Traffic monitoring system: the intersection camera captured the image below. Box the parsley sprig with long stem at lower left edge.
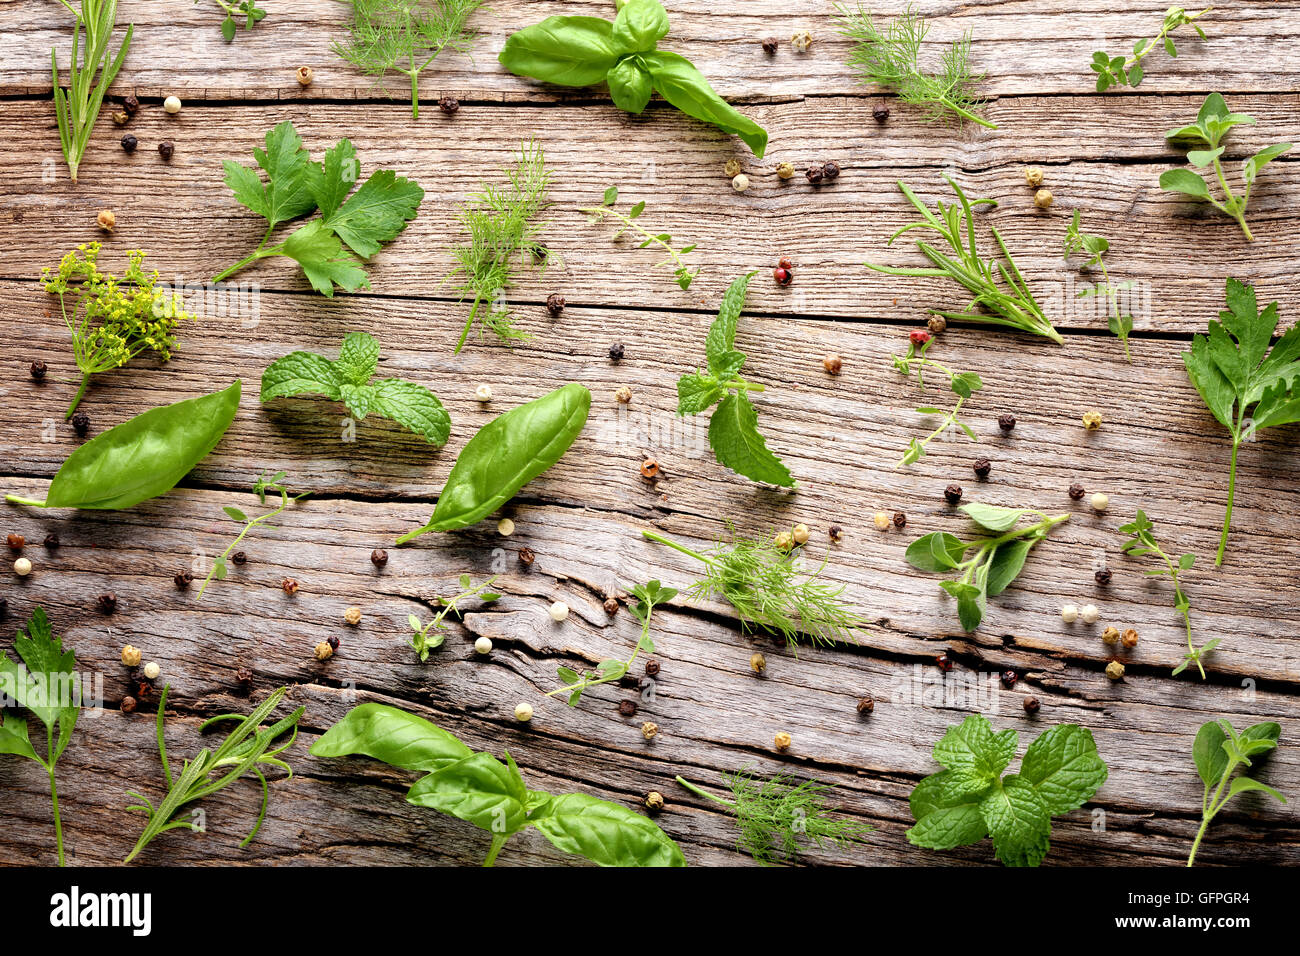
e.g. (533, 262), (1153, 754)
(0, 607), (81, 866)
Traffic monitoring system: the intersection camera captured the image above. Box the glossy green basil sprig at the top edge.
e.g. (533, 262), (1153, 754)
(498, 0), (767, 159)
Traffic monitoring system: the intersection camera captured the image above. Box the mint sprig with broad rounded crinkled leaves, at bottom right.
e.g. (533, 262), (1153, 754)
(907, 714), (1108, 866)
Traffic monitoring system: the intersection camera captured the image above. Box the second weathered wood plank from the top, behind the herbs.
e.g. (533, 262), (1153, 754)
(0, 95), (1300, 332)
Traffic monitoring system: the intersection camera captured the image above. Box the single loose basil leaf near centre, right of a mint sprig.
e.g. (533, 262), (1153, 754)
(398, 384), (592, 544)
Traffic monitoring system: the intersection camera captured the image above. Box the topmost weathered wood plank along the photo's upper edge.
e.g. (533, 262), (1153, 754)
(0, 0), (1300, 98)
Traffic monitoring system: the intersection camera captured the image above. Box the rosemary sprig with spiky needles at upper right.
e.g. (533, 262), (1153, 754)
(866, 177), (1063, 345)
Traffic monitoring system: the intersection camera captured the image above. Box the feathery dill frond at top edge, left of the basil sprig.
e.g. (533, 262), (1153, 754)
(332, 0), (484, 120)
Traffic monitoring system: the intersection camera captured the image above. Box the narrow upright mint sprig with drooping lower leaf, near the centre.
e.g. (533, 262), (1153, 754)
(677, 272), (794, 488)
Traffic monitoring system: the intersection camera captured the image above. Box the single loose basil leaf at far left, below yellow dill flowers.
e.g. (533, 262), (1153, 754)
(31, 380), (239, 510)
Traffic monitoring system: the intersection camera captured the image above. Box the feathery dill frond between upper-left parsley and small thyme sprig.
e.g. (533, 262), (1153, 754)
(447, 139), (551, 352)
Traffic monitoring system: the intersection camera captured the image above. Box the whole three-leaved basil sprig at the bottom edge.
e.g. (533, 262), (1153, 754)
(312, 704), (686, 866)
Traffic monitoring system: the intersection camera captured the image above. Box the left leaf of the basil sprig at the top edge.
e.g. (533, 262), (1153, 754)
(498, 17), (619, 86)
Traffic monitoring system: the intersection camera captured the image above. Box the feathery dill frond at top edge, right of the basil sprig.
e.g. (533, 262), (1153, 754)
(836, 4), (997, 130)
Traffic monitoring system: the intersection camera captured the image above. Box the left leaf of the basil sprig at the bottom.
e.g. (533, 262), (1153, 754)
(311, 702), (473, 771)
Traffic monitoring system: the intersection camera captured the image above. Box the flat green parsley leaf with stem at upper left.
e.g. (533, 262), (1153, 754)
(212, 120), (424, 297)
